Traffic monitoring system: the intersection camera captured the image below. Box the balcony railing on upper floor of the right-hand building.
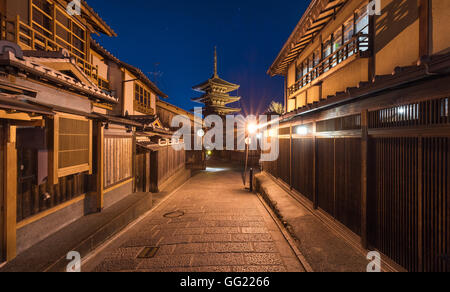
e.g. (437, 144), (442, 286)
(288, 33), (369, 96)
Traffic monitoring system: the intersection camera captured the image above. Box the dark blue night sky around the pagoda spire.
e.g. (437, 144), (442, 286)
(88, 0), (309, 114)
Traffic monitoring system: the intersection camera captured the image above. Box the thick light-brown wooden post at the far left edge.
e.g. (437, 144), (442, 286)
(3, 125), (17, 261)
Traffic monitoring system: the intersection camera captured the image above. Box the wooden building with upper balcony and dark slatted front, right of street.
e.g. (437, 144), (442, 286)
(264, 0), (450, 271)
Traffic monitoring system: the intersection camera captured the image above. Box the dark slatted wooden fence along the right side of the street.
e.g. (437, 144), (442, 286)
(263, 98), (450, 272)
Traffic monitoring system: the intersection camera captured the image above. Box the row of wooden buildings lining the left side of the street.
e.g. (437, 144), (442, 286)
(0, 0), (185, 262)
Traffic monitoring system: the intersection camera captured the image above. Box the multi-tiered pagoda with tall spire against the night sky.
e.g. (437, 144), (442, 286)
(192, 49), (241, 116)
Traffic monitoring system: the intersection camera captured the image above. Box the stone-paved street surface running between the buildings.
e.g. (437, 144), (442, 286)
(82, 168), (303, 272)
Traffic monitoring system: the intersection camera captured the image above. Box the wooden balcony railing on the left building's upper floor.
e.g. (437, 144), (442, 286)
(0, 15), (99, 84)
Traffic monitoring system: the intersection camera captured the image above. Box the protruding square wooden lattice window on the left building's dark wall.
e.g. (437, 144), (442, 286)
(53, 114), (92, 183)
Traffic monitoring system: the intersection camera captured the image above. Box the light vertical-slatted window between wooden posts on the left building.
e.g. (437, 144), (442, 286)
(104, 137), (133, 188)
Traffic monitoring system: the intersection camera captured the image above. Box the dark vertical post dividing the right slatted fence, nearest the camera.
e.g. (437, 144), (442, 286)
(361, 110), (369, 249)
